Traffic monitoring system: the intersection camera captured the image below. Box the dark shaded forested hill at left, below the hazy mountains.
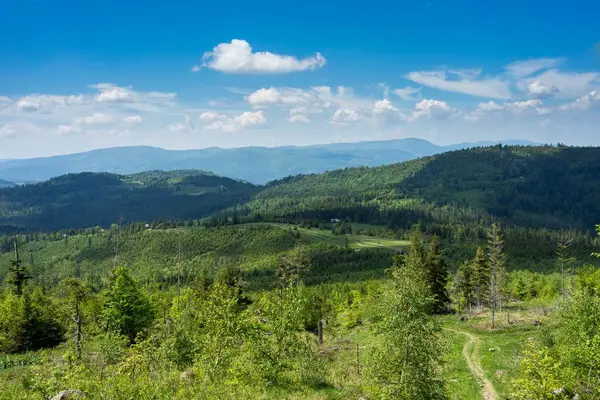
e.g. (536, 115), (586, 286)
(0, 170), (257, 230)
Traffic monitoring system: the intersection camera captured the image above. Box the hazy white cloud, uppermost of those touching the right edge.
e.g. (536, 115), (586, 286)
(520, 69), (600, 98)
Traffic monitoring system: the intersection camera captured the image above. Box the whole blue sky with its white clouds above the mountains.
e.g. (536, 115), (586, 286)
(0, 0), (600, 158)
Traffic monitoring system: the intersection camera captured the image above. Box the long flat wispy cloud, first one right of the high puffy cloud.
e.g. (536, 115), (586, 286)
(406, 71), (511, 99)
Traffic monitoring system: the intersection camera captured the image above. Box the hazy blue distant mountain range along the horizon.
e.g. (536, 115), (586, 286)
(0, 139), (536, 187)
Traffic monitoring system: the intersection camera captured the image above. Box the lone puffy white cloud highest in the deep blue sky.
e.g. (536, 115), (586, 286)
(199, 39), (326, 74)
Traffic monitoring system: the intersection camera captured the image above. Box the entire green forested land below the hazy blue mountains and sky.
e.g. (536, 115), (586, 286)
(0, 146), (600, 400)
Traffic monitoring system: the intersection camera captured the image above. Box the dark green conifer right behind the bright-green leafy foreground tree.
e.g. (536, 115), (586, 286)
(425, 235), (450, 314)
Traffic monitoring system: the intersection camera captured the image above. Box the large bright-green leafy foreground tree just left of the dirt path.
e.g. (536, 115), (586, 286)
(367, 232), (446, 399)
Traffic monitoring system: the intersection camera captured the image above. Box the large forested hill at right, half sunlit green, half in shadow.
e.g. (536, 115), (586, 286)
(247, 146), (600, 229)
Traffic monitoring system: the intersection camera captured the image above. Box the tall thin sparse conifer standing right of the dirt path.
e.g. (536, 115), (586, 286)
(487, 223), (506, 329)
